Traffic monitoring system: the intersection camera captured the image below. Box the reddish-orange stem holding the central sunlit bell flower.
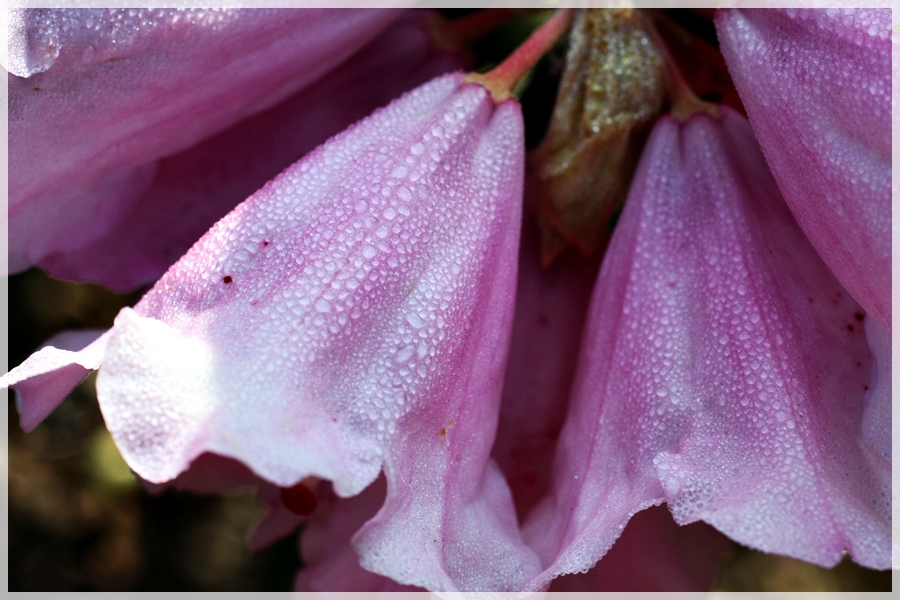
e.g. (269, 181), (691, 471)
(466, 8), (572, 102)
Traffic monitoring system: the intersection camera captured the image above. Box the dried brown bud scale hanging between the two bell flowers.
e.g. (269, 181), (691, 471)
(532, 9), (666, 263)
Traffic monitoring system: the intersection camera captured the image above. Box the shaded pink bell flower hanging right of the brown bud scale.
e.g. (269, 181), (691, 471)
(524, 108), (890, 589)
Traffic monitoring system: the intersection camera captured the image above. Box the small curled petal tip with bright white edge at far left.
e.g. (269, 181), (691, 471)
(0, 329), (109, 431)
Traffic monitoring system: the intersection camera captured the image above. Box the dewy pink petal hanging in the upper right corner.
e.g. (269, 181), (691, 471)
(716, 9), (891, 331)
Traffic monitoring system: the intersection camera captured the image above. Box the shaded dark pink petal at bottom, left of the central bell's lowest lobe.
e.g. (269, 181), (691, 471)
(294, 477), (421, 592)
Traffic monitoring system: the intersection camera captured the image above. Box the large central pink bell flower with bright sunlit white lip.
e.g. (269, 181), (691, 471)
(97, 74), (537, 589)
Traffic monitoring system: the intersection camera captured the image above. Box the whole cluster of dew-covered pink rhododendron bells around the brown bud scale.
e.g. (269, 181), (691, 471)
(0, 5), (891, 591)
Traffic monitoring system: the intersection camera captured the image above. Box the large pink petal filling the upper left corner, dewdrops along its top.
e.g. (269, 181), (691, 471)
(6, 9), (398, 272)
